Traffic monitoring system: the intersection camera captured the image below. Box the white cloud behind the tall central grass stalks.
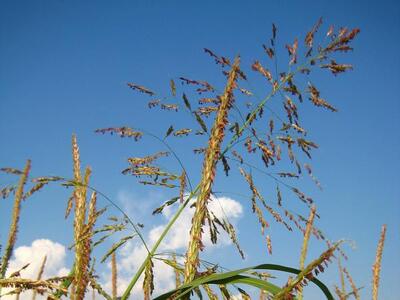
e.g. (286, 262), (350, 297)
(104, 197), (243, 299)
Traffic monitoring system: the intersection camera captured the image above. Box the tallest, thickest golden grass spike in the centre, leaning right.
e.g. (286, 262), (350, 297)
(185, 57), (240, 283)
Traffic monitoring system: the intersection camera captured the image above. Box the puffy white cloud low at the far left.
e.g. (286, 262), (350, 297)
(2, 239), (69, 300)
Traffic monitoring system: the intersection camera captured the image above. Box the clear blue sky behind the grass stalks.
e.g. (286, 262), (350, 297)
(0, 0), (400, 300)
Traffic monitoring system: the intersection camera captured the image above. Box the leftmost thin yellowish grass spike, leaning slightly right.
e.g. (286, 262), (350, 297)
(0, 160), (31, 280)
